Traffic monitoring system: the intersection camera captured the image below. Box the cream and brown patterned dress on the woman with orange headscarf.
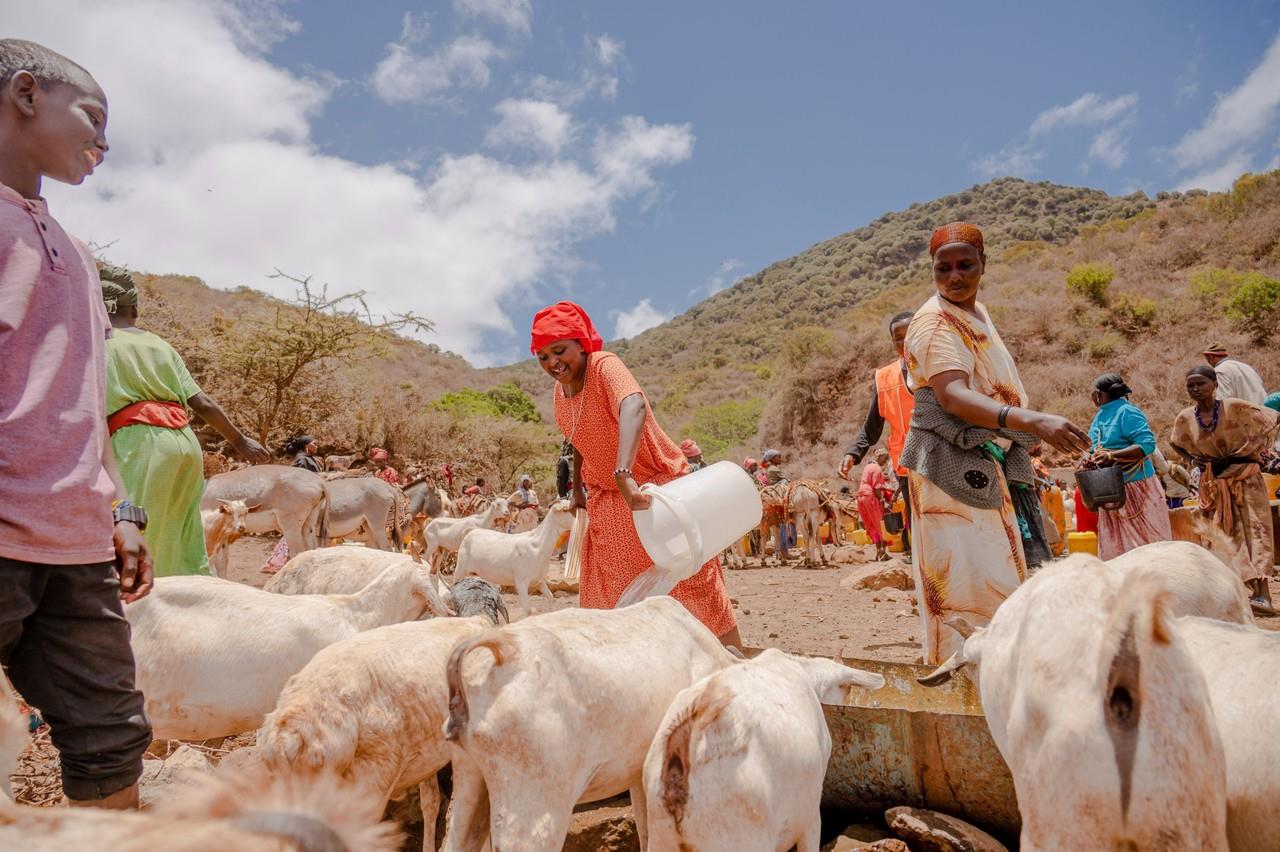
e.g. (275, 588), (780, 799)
(906, 296), (1027, 665)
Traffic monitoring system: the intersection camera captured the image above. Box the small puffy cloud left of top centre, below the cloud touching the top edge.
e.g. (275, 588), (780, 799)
(374, 36), (502, 104)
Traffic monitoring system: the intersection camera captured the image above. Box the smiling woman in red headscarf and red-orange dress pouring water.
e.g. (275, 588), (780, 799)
(530, 302), (742, 647)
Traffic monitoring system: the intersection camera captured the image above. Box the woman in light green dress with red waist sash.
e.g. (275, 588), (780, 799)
(100, 266), (270, 577)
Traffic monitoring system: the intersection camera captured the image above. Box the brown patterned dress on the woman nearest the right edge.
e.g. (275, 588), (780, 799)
(1170, 399), (1280, 582)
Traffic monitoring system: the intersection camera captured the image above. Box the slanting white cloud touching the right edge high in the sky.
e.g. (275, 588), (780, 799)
(1172, 36), (1280, 169)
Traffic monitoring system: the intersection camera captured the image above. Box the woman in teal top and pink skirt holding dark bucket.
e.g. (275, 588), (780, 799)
(1089, 372), (1174, 559)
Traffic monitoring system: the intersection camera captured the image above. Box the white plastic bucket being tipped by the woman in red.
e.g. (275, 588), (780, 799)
(617, 462), (764, 606)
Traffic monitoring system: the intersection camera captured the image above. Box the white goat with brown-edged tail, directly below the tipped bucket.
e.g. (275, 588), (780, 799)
(444, 596), (736, 852)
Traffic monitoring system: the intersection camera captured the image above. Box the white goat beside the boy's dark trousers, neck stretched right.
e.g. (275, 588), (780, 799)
(124, 572), (448, 739)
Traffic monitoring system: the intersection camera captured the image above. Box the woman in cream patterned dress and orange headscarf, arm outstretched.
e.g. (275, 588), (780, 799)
(906, 223), (1089, 665)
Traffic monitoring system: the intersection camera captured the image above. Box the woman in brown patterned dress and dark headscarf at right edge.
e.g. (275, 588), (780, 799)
(1170, 365), (1280, 614)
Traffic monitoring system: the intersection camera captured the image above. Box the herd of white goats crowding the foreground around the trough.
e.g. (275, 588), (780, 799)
(0, 491), (1280, 852)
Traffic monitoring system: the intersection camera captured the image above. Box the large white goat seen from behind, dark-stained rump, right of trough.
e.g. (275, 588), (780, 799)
(922, 556), (1228, 852)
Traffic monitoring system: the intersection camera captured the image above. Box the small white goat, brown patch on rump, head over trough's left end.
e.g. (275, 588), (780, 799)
(644, 650), (884, 852)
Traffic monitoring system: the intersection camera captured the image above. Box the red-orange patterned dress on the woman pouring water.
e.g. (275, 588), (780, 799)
(556, 352), (736, 636)
